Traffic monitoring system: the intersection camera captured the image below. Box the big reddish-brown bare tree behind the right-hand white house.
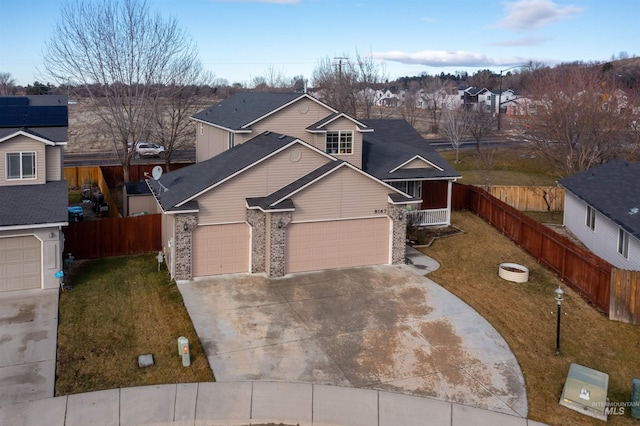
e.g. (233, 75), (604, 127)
(525, 64), (633, 177)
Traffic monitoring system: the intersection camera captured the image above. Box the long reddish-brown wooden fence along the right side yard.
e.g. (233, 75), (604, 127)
(452, 184), (612, 314)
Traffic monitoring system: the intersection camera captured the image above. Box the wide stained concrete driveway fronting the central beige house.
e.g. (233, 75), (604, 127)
(178, 265), (527, 417)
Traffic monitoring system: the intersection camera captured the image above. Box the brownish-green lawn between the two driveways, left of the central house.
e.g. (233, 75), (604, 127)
(55, 255), (214, 396)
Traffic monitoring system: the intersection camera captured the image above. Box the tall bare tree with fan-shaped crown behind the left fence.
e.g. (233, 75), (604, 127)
(44, 0), (204, 182)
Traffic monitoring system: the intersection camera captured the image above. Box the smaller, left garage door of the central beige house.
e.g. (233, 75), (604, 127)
(193, 223), (250, 277)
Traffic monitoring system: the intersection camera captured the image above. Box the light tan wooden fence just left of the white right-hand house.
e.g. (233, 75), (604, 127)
(488, 185), (564, 212)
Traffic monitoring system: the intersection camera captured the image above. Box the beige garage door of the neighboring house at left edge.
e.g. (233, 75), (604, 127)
(0, 236), (42, 291)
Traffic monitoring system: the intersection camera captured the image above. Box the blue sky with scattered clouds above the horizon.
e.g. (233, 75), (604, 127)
(0, 0), (640, 85)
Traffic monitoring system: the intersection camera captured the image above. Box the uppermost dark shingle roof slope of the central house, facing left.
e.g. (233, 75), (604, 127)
(193, 92), (306, 130)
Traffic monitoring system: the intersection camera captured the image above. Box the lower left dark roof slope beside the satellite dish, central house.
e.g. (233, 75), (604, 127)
(148, 132), (296, 211)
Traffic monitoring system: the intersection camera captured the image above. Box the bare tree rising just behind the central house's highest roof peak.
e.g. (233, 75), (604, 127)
(313, 53), (385, 118)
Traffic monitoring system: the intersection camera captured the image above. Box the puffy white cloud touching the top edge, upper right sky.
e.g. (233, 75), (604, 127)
(496, 0), (582, 30)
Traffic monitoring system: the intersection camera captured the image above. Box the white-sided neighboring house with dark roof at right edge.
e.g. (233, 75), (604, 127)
(559, 160), (640, 270)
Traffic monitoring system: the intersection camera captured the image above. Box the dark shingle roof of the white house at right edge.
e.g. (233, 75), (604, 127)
(558, 160), (640, 238)
